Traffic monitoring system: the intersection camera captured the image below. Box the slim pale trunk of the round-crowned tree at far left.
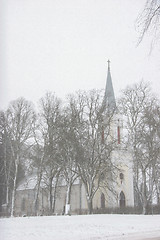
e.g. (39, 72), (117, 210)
(11, 158), (19, 217)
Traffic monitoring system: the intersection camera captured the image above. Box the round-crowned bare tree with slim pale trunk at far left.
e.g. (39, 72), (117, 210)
(6, 98), (35, 216)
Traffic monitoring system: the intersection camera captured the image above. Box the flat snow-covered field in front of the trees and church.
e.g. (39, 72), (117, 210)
(0, 215), (160, 240)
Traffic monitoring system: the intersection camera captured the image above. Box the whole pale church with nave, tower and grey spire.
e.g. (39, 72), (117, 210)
(15, 61), (134, 216)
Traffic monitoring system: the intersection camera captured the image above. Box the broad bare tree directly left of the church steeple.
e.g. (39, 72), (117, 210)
(67, 90), (114, 214)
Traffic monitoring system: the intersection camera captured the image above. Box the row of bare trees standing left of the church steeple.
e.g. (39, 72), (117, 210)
(0, 91), (114, 216)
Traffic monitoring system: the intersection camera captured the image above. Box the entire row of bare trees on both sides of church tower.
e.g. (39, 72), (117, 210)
(0, 83), (160, 216)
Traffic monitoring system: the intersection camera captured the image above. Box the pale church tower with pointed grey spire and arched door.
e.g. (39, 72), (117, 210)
(103, 60), (134, 209)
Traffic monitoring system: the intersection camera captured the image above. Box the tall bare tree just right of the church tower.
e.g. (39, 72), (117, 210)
(121, 82), (159, 214)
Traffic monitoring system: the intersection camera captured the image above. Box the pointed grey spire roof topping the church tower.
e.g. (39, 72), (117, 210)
(104, 60), (116, 110)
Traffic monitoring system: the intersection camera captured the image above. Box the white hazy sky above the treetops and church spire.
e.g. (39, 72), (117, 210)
(0, 0), (160, 109)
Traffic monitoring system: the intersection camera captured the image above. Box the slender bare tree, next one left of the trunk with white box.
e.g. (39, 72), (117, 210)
(39, 93), (61, 213)
